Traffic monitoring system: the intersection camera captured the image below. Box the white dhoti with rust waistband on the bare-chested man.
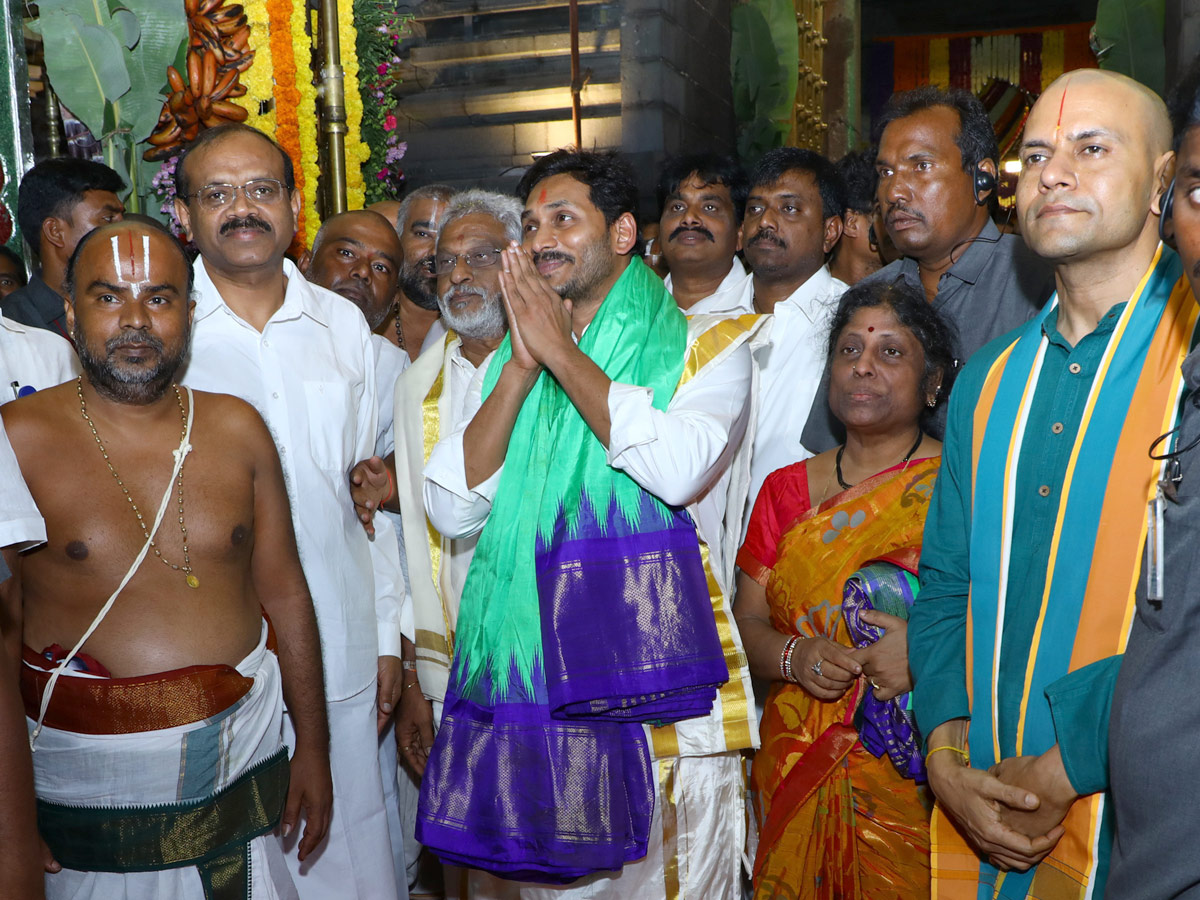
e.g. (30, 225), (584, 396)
(23, 623), (298, 900)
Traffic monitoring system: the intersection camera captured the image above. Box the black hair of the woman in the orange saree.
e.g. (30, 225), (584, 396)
(826, 278), (958, 416)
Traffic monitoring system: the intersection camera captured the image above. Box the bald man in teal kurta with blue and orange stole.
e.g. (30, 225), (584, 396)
(908, 68), (1176, 900)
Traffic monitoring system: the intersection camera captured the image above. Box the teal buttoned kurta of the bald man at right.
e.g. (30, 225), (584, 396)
(908, 304), (1126, 793)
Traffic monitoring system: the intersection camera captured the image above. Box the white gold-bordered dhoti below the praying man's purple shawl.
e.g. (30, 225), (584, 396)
(469, 751), (746, 900)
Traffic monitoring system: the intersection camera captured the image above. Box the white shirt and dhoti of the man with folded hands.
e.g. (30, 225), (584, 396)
(425, 321), (757, 900)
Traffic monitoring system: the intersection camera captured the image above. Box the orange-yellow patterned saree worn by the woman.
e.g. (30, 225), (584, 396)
(751, 458), (941, 900)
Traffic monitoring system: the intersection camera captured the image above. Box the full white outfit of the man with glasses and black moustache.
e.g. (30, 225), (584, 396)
(181, 259), (407, 900)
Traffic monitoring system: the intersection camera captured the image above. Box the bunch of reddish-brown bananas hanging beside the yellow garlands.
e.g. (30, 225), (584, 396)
(143, 0), (254, 160)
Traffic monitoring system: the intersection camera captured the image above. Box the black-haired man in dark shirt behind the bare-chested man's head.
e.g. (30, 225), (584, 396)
(0, 157), (125, 340)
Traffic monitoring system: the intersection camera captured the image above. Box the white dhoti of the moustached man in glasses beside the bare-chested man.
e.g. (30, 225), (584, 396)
(283, 682), (408, 900)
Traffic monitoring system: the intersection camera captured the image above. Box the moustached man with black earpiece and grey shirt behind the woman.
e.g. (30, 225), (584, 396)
(802, 85), (1054, 454)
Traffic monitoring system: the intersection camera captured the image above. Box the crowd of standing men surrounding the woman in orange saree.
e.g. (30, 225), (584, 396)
(0, 60), (1200, 900)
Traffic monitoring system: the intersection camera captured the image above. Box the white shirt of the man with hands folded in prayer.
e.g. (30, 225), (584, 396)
(425, 336), (752, 573)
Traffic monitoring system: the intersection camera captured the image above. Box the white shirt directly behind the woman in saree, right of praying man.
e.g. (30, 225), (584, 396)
(743, 265), (848, 509)
